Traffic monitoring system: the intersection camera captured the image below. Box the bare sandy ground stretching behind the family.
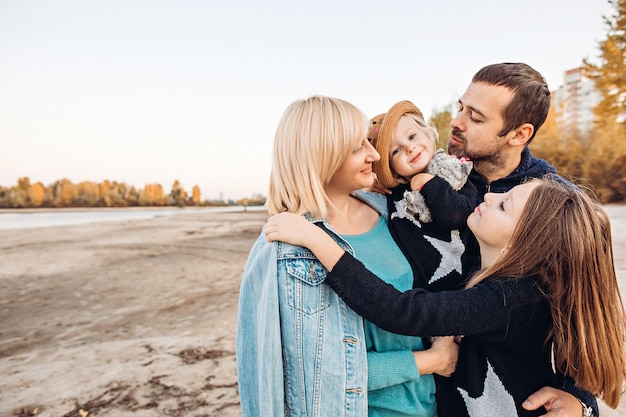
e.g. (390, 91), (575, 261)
(0, 206), (626, 417)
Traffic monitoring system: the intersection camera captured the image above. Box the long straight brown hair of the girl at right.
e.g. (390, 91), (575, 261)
(468, 179), (626, 408)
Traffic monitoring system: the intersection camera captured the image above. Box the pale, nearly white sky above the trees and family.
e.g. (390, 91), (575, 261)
(0, 0), (613, 199)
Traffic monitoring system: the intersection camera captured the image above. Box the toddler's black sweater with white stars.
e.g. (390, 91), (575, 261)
(387, 176), (478, 291)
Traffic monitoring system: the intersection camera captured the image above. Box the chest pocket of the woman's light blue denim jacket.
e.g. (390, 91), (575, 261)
(287, 258), (332, 314)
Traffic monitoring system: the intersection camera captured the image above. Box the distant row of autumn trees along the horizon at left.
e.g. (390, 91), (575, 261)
(0, 177), (265, 208)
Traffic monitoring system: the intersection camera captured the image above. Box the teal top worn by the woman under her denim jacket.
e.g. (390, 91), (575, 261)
(342, 216), (437, 417)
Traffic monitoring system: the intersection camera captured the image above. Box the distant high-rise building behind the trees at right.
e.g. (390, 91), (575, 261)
(552, 67), (602, 135)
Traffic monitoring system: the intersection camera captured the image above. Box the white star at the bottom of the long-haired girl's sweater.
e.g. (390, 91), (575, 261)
(457, 361), (517, 417)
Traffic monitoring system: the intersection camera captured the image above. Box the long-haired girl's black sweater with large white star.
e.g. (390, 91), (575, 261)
(325, 253), (557, 417)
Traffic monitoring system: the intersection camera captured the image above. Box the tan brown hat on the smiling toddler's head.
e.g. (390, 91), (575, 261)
(367, 100), (424, 188)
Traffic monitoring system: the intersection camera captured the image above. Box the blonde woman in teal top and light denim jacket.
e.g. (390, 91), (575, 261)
(237, 96), (458, 417)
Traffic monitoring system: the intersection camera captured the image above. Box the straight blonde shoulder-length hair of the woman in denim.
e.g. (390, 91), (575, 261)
(267, 96), (368, 217)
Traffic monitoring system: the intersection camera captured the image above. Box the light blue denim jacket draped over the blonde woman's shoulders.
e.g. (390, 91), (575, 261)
(237, 193), (387, 417)
